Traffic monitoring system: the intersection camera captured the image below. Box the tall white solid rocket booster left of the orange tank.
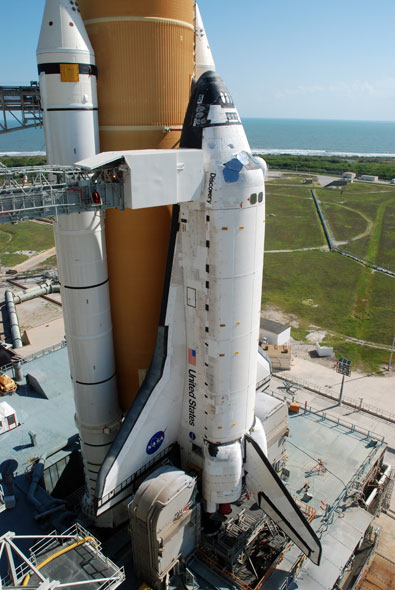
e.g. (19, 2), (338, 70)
(37, 0), (121, 504)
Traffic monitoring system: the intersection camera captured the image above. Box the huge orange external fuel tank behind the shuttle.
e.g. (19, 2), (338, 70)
(78, 0), (195, 409)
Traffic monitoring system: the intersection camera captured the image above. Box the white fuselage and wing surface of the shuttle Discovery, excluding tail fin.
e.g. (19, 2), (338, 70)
(99, 91), (265, 511)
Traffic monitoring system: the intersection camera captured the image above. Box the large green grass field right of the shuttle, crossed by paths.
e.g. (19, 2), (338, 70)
(262, 179), (395, 371)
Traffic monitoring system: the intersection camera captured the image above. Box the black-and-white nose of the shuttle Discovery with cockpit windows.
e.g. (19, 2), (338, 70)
(180, 71), (241, 149)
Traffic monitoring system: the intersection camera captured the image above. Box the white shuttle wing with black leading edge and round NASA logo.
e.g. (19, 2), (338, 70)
(95, 205), (187, 516)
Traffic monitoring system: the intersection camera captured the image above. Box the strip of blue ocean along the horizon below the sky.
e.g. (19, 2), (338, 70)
(0, 118), (395, 157)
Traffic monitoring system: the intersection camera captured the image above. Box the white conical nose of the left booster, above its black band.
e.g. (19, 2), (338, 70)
(37, 0), (95, 64)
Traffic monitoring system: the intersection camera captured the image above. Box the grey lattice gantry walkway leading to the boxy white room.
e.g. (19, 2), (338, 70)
(0, 162), (124, 223)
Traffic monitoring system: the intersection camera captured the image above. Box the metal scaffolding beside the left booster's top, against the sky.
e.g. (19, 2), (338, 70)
(0, 82), (43, 134)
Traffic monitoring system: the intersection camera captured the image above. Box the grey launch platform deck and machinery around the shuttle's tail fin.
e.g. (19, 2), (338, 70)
(189, 411), (386, 590)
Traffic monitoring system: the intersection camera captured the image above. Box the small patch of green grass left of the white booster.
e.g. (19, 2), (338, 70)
(0, 221), (55, 266)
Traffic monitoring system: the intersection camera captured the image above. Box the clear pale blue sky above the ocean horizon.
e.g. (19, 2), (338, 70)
(0, 0), (395, 121)
